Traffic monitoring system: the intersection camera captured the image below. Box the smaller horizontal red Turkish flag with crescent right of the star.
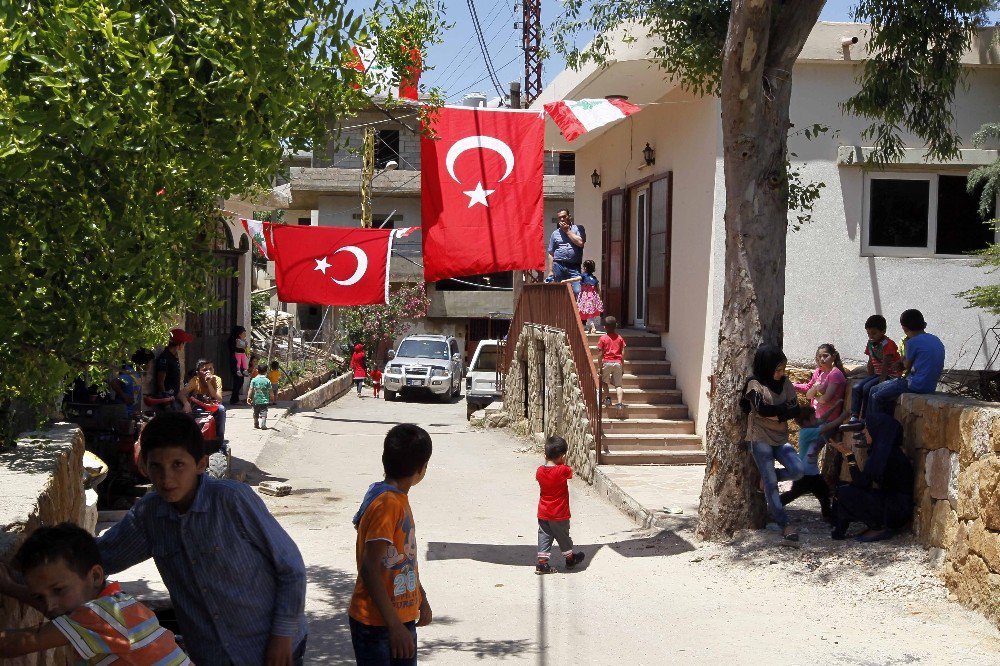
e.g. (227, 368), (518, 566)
(270, 224), (394, 305)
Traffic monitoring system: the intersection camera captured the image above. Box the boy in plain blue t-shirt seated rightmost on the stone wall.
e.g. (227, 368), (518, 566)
(869, 310), (944, 416)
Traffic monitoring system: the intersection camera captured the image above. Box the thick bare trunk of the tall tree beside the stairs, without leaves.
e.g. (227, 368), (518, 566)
(698, 0), (824, 539)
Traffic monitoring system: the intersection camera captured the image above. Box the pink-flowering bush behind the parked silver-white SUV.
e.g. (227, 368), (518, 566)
(337, 282), (430, 358)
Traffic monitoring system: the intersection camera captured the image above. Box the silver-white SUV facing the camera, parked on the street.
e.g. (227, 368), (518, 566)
(382, 335), (462, 402)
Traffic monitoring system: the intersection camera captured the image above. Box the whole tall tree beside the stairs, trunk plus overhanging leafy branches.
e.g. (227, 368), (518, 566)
(553, 0), (994, 538)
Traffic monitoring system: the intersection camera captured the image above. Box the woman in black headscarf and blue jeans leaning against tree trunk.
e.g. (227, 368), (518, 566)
(740, 344), (803, 541)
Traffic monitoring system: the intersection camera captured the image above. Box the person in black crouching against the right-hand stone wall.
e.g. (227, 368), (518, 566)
(830, 413), (913, 543)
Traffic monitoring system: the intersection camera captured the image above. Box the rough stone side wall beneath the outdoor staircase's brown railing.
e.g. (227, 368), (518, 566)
(503, 324), (597, 483)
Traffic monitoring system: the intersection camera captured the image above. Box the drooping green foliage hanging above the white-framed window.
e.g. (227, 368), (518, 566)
(843, 0), (997, 163)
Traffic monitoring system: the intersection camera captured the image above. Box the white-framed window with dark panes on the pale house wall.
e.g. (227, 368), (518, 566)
(862, 172), (996, 257)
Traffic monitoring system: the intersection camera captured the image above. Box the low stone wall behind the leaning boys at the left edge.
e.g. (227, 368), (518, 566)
(0, 423), (84, 665)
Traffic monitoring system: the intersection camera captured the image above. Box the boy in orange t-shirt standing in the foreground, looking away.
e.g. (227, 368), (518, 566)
(347, 423), (431, 664)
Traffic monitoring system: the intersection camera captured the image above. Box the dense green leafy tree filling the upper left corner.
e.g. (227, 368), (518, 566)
(0, 0), (441, 434)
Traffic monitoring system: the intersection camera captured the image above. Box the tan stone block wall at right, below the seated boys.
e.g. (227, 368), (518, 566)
(896, 393), (1000, 626)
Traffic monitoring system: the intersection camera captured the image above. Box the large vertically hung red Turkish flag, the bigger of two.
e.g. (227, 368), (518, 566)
(420, 107), (545, 282)
